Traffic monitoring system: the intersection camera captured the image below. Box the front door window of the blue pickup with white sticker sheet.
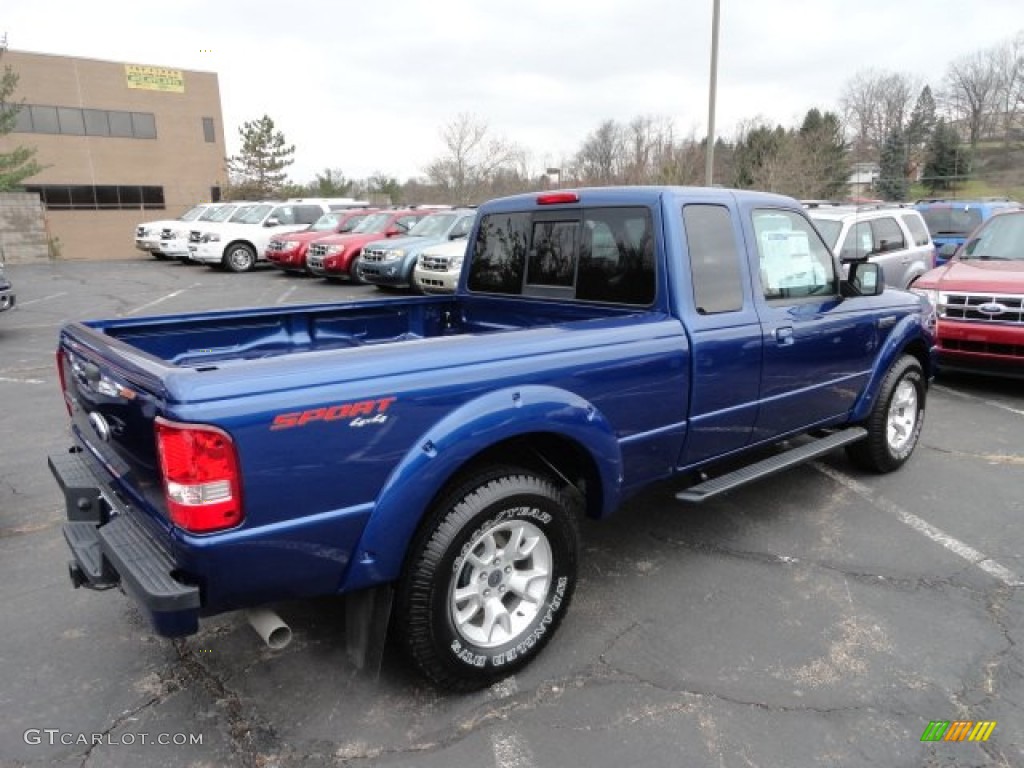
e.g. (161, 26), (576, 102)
(753, 209), (838, 300)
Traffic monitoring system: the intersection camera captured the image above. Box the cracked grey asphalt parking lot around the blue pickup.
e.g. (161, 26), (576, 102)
(0, 258), (1024, 768)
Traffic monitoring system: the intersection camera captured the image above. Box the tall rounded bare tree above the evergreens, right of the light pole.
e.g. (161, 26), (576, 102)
(840, 70), (921, 158)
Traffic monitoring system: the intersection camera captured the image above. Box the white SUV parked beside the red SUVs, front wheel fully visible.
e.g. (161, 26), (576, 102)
(188, 202), (330, 272)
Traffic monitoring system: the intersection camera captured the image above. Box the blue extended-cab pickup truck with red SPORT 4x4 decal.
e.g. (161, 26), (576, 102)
(50, 187), (935, 689)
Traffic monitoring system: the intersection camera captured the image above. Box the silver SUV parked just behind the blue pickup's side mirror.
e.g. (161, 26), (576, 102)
(804, 202), (935, 289)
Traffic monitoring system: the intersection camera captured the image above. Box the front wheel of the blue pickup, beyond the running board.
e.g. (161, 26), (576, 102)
(846, 354), (927, 473)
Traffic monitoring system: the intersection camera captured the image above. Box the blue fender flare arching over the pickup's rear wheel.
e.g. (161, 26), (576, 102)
(341, 385), (623, 592)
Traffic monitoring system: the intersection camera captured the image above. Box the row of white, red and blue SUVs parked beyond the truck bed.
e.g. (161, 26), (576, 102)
(135, 200), (476, 293)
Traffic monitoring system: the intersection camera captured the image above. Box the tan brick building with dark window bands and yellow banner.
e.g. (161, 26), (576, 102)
(0, 50), (226, 259)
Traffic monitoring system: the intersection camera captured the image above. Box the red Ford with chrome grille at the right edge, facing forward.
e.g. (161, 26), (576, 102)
(910, 210), (1024, 378)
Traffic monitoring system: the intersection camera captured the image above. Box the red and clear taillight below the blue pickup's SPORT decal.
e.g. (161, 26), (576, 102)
(156, 417), (242, 534)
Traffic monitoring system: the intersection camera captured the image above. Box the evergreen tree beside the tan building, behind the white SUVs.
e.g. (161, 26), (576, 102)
(227, 115), (295, 200)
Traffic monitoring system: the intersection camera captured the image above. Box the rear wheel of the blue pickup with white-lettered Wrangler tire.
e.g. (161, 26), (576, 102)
(396, 467), (579, 691)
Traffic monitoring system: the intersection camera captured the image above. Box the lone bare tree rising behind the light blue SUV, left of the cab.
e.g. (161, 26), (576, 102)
(426, 113), (524, 203)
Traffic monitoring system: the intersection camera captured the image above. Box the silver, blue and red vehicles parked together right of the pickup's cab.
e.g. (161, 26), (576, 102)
(804, 198), (1024, 378)
